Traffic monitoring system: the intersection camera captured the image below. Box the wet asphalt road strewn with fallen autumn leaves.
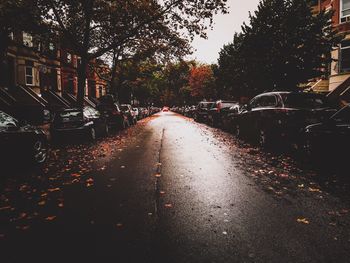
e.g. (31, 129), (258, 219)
(0, 112), (350, 263)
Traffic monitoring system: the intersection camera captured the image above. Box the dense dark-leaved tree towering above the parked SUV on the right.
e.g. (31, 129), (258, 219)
(219, 0), (339, 96)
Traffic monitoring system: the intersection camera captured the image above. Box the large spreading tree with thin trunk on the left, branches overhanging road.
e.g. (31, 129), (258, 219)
(38, 0), (226, 104)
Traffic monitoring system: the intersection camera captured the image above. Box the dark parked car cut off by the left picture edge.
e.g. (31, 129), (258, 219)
(0, 111), (48, 164)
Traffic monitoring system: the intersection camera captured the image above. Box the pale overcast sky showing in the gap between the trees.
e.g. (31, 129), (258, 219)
(190, 0), (259, 64)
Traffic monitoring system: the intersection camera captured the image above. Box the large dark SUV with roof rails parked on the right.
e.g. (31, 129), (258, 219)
(235, 92), (336, 146)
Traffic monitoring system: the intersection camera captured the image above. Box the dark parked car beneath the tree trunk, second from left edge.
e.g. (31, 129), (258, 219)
(50, 106), (109, 140)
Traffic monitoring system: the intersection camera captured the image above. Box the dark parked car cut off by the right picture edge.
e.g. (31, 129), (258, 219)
(305, 106), (350, 162)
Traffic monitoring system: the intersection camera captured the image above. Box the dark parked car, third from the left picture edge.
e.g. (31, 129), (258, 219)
(97, 101), (129, 129)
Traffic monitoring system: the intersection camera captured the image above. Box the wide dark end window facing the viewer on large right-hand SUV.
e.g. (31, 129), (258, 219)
(282, 93), (329, 109)
